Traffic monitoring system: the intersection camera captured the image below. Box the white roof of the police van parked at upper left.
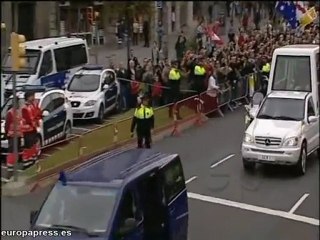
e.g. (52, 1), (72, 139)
(26, 37), (85, 50)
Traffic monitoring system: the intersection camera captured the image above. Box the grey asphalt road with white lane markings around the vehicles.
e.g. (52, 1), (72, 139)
(1, 109), (319, 240)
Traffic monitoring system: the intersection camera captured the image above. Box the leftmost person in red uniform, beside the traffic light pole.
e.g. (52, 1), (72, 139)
(1, 98), (23, 182)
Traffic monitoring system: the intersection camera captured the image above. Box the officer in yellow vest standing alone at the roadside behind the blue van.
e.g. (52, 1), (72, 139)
(131, 95), (154, 148)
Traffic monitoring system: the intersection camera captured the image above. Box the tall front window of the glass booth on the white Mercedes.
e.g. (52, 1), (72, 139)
(272, 55), (312, 92)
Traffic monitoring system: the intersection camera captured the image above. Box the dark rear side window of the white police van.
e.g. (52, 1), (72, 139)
(54, 44), (88, 72)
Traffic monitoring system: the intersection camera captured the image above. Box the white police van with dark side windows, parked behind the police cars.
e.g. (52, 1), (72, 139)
(1, 37), (89, 97)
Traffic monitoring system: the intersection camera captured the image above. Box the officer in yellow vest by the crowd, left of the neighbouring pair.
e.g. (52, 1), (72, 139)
(168, 61), (181, 103)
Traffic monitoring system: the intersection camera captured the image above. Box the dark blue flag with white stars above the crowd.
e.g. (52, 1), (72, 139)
(276, 1), (298, 29)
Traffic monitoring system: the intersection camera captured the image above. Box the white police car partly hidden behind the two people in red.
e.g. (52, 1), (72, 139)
(1, 85), (73, 152)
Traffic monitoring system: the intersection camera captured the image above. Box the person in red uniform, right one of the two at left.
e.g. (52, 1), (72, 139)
(22, 91), (38, 169)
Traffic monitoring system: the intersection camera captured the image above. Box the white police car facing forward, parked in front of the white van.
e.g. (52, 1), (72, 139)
(65, 65), (120, 123)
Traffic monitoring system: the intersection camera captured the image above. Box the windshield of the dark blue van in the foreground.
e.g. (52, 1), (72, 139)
(35, 184), (118, 233)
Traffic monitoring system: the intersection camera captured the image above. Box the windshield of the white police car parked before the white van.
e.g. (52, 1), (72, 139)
(68, 74), (100, 92)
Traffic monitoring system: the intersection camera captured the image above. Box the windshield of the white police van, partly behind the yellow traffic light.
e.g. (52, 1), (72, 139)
(1, 49), (41, 74)
